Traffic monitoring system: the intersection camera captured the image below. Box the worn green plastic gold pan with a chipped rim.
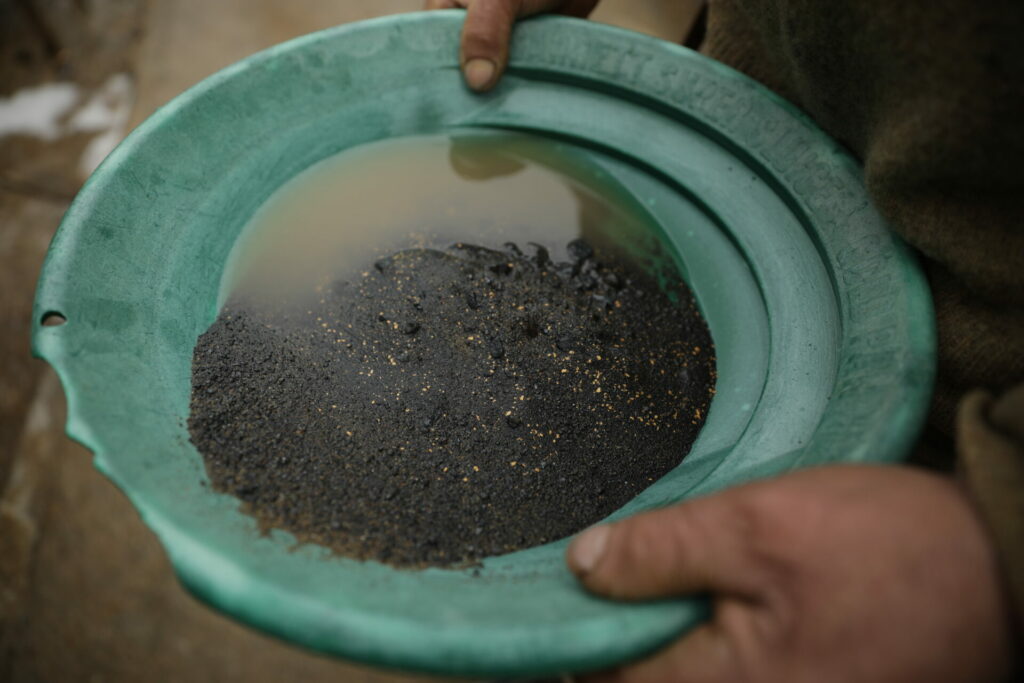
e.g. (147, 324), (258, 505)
(33, 12), (935, 677)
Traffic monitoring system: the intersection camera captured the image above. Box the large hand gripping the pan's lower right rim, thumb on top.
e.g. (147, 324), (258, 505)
(567, 466), (1013, 683)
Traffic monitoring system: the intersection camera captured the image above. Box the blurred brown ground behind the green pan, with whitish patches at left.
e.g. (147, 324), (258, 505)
(0, 0), (699, 683)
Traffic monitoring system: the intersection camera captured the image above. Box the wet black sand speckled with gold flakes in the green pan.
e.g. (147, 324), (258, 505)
(188, 242), (715, 565)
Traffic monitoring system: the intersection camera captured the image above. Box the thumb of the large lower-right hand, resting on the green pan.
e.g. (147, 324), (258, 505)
(566, 489), (763, 600)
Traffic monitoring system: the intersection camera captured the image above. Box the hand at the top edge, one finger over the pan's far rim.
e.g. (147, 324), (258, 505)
(426, 0), (598, 92)
